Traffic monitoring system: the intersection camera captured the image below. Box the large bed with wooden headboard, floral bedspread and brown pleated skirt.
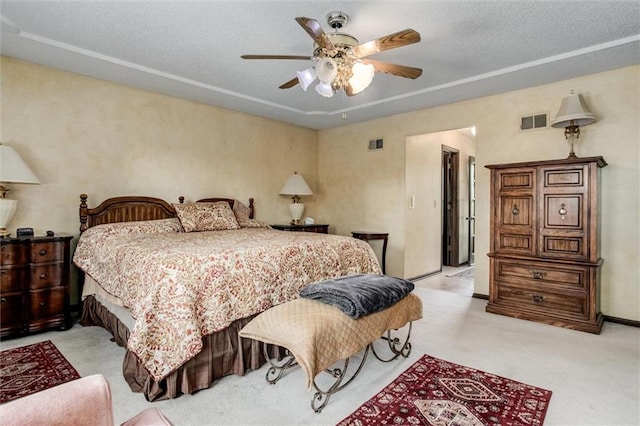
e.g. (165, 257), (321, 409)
(74, 194), (380, 401)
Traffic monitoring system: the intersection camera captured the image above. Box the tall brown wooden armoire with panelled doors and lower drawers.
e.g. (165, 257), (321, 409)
(486, 157), (607, 334)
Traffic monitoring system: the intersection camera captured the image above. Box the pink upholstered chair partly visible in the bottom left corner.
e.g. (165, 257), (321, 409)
(0, 374), (172, 426)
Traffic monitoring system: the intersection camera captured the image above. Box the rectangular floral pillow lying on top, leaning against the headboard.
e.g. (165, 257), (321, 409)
(173, 201), (240, 232)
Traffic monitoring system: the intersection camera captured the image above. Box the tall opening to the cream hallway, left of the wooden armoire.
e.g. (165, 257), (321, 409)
(404, 127), (475, 278)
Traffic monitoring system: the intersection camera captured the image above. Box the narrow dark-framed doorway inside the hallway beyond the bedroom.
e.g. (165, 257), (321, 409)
(442, 145), (460, 266)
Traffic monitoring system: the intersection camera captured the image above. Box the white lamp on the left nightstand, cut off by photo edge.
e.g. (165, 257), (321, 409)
(0, 143), (40, 238)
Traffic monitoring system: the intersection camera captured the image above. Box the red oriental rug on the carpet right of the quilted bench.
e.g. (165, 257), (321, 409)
(339, 355), (551, 426)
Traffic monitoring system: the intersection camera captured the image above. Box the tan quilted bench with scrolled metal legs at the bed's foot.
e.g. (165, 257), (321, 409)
(240, 274), (422, 412)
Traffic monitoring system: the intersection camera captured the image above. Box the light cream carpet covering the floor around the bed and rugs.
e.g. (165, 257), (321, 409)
(0, 285), (640, 426)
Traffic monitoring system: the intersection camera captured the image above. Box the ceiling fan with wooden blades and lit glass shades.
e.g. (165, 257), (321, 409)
(241, 11), (422, 97)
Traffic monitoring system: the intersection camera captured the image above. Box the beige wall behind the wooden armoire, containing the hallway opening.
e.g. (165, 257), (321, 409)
(318, 66), (640, 320)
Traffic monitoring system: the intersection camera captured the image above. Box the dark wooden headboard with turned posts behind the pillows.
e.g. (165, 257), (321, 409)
(79, 194), (255, 233)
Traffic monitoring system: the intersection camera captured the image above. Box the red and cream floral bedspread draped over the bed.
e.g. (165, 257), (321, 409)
(74, 219), (380, 380)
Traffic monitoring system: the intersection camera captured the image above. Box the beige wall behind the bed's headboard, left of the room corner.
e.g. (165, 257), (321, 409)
(0, 57), (318, 302)
